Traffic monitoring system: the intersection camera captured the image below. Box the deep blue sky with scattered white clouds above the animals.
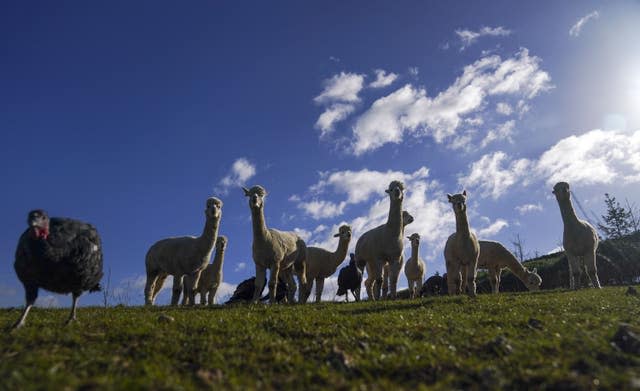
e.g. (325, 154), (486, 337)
(0, 1), (640, 306)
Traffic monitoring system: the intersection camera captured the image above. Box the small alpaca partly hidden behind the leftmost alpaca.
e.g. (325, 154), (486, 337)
(182, 235), (227, 305)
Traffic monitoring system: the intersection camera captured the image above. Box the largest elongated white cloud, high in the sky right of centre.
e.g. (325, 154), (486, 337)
(351, 49), (552, 156)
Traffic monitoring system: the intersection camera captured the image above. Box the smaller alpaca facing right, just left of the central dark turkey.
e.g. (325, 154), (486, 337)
(301, 225), (351, 303)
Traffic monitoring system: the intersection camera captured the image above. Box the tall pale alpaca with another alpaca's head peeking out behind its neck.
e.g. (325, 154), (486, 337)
(355, 181), (404, 300)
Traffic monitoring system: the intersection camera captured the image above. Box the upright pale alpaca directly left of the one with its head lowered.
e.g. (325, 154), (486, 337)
(444, 190), (480, 297)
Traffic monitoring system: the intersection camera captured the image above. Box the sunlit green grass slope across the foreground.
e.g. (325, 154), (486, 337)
(0, 287), (640, 390)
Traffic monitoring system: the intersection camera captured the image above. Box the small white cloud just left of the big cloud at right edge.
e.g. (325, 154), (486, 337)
(458, 151), (531, 199)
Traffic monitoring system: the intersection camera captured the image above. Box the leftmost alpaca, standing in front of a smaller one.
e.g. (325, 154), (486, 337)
(144, 197), (222, 305)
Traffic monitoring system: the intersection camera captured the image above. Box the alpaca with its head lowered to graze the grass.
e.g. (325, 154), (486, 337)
(478, 240), (542, 293)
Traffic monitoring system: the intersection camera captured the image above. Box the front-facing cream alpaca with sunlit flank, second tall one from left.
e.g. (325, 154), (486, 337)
(242, 186), (307, 303)
